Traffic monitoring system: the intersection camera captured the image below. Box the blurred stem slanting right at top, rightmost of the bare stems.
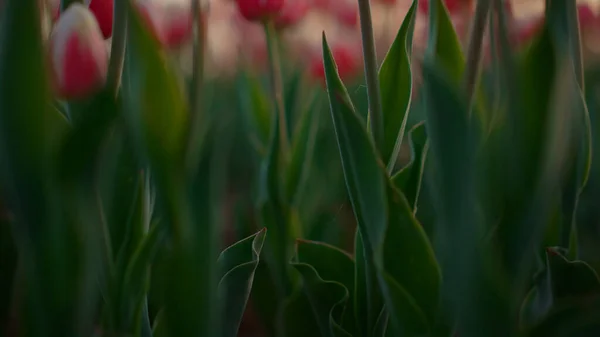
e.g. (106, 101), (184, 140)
(464, 0), (491, 111)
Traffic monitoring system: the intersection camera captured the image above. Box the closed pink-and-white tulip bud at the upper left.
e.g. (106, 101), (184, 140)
(50, 3), (108, 99)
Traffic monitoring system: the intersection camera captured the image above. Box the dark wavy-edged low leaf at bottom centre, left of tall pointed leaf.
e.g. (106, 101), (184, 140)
(292, 262), (352, 337)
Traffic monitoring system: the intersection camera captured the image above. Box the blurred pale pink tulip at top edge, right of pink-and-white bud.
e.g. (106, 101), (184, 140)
(137, 1), (194, 48)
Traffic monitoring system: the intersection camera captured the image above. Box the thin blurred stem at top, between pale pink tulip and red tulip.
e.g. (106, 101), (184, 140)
(187, 0), (207, 174)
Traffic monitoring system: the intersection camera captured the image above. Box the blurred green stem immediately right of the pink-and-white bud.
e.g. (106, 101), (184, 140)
(106, 0), (127, 97)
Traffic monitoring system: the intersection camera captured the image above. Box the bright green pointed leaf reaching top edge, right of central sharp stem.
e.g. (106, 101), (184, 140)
(379, 1), (418, 168)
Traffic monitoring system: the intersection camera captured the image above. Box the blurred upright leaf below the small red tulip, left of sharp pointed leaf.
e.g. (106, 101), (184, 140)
(286, 90), (320, 205)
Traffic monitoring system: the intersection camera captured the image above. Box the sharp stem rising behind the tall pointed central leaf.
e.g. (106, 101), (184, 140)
(358, 0), (383, 150)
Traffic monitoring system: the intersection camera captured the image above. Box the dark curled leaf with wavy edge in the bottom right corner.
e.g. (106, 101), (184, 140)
(520, 247), (600, 329)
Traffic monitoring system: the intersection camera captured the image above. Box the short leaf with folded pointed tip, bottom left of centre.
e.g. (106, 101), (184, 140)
(217, 229), (267, 337)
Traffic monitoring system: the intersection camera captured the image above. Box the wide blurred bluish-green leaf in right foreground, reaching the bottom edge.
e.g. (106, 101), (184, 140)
(423, 62), (513, 337)
